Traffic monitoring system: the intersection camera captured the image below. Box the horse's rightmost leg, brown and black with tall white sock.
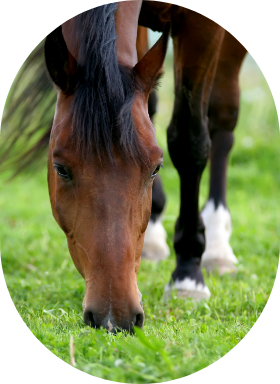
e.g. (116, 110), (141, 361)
(201, 31), (247, 275)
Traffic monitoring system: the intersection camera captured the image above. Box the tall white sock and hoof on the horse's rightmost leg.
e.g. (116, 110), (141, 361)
(201, 200), (238, 275)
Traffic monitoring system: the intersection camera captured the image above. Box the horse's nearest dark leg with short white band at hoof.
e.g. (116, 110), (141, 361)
(165, 7), (224, 299)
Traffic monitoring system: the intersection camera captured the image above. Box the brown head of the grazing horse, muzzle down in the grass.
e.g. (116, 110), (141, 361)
(45, 11), (169, 332)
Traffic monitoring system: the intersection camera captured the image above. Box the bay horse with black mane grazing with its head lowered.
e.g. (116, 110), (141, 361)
(2, 0), (246, 332)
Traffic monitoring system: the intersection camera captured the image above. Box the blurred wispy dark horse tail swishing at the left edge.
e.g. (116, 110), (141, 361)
(0, 39), (56, 177)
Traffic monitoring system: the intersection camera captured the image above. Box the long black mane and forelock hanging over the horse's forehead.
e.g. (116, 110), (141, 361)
(69, 3), (145, 164)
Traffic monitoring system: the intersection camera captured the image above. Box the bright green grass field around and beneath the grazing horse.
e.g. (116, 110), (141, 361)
(0, 36), (280, 383)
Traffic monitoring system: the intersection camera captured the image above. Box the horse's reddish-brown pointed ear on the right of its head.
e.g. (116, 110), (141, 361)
(134, 23), (170, 94)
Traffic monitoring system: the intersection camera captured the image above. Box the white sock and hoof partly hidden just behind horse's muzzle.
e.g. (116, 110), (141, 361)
(142, 220), (170, 261)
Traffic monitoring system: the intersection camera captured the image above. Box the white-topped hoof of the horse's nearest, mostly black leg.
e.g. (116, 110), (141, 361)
(163, 277), (211, 300)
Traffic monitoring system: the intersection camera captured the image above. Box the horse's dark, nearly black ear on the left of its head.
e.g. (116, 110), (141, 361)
(45, 25), (77, 94)
